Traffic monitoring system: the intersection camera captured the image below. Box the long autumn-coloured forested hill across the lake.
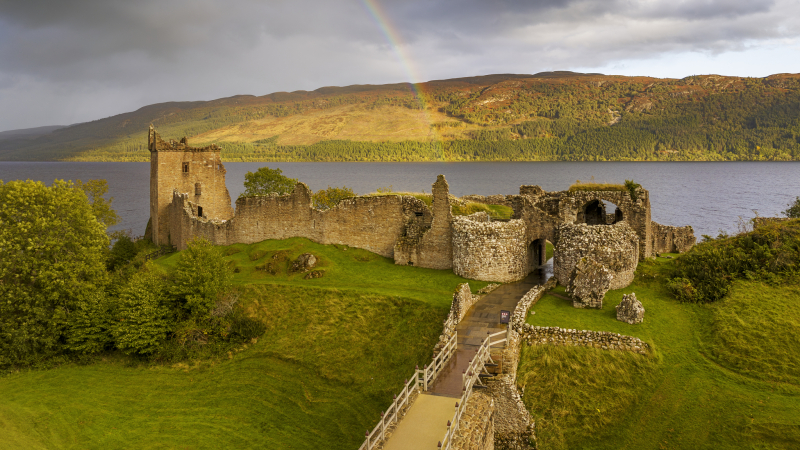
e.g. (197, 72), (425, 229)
(0, 72), (800, 161)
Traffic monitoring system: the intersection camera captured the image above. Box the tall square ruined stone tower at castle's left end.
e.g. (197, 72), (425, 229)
(147, 125), (233, 245)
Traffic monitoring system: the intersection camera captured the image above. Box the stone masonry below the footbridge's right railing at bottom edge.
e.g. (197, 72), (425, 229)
(450, 391), (495, 450)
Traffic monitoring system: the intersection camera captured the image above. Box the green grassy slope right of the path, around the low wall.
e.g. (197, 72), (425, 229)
(520, 258), (800, 449)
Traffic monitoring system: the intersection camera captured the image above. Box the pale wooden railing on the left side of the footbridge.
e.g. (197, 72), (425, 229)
(358, 332), (458, 450)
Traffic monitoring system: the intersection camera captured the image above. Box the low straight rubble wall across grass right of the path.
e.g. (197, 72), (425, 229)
(520, 324), (650, 355)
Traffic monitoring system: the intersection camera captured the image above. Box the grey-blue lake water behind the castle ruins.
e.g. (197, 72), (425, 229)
(0, 162), (800, 238)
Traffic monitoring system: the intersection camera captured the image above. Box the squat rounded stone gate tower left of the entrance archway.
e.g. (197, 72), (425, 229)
(453, 215), (529, 282)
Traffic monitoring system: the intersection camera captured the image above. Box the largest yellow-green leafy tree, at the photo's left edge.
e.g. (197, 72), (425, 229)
(0, 180), (108, 366)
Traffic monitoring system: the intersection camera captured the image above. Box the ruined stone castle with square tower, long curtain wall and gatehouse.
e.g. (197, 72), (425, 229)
(148, 127), (695, 282)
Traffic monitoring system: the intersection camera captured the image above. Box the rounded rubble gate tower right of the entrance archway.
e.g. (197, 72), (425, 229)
(553, 222), (640, 290)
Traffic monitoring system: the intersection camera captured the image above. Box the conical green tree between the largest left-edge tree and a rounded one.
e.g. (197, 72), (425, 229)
(111, 263), (171, 355)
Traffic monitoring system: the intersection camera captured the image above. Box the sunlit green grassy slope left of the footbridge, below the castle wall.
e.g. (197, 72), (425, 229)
(0, 239), (486, 449)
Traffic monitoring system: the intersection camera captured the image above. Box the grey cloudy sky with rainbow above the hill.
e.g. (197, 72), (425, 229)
(0, 0), (800, 131)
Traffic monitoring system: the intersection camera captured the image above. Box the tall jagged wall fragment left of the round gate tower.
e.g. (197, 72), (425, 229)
(394, 175), (453, 269)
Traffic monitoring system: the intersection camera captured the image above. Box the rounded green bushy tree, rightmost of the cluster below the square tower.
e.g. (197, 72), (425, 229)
(169, 239), (233, 318)
